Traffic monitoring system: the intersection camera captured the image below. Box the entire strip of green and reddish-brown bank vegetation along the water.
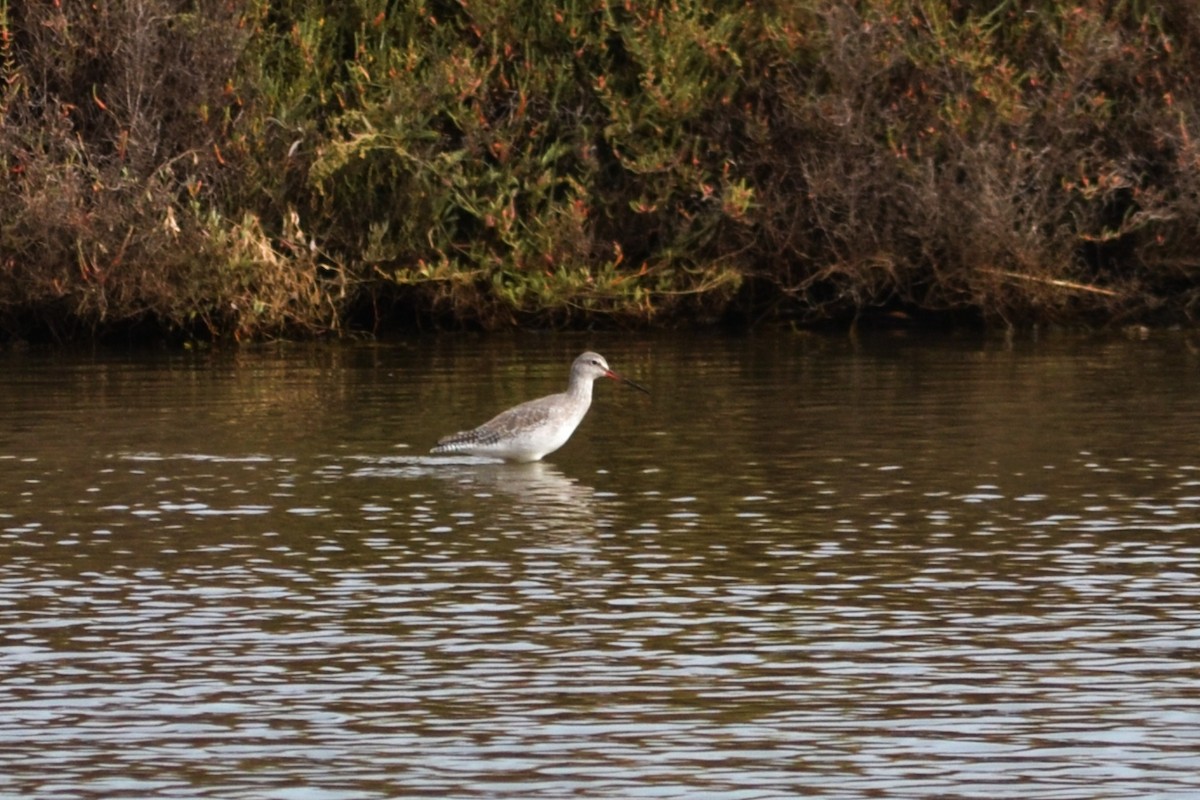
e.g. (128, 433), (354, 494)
(0, 0), (1200, 338)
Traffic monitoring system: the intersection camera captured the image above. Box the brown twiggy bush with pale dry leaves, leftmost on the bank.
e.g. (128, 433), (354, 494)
(0, 0), (340, 338)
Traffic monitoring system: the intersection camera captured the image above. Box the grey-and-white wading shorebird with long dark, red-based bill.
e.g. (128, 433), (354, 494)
(430, 353), (650, 462)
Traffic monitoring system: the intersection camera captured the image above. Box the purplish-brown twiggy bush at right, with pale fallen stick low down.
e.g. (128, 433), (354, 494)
(754, 2), (1200, 319)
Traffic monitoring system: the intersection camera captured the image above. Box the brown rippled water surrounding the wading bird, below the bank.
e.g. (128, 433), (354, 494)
(0, 335), (1200, 799)
